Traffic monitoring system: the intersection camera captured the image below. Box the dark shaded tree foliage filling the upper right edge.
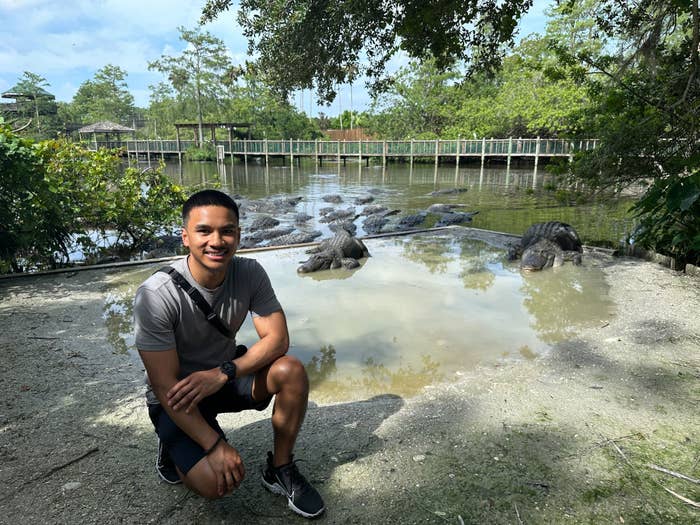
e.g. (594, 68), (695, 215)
(558, 0), (700, 264)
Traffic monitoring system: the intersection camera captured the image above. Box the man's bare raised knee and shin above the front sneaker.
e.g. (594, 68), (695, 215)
(253, 355), (309, 467)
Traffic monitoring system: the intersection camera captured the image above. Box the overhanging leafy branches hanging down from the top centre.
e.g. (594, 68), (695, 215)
(202, 0), (532, 102)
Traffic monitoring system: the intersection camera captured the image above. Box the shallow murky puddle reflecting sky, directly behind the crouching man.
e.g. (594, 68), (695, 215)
(105, 228), (613, 401)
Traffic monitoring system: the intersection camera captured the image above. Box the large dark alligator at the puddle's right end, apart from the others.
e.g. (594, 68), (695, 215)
(508, 221), (583, 271)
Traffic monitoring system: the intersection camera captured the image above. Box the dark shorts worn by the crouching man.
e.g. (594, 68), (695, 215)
(148, 375), (272, 474)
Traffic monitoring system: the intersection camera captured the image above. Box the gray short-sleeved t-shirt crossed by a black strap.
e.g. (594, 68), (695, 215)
(134, 257), (282, 378)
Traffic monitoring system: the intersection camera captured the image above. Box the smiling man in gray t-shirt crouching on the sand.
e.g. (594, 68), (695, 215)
(134, 190), (325, 518)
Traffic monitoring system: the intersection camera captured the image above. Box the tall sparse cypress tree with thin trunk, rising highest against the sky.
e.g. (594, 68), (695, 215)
(148, 27), (232, 145)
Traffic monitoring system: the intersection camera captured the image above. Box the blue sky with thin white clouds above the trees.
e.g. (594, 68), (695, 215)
(0, 0), (553, 115)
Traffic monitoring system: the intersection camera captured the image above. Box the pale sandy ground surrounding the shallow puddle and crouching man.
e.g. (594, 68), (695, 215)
(0, 243), (700, 524)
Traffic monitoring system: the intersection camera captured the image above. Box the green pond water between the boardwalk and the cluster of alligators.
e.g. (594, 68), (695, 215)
(161, 159), (632, 244)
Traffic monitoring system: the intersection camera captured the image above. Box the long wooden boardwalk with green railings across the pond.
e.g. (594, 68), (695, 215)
(88, 137), (597, 171)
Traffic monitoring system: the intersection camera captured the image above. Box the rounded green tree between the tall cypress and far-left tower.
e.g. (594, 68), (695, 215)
(71, 64), (135, 123)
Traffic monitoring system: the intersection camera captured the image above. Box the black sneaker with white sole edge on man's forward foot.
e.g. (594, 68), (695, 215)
(262, 452), (326, 518)
